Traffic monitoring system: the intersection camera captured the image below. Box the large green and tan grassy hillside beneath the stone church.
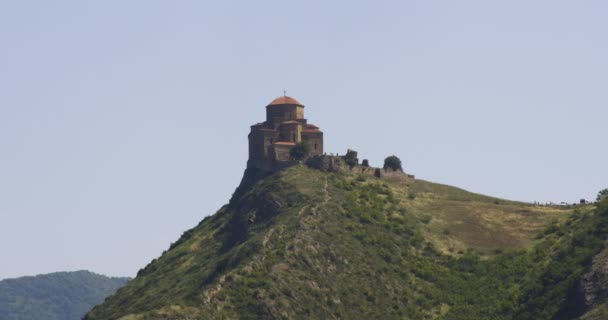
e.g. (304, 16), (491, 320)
(86, 165), (608, 320)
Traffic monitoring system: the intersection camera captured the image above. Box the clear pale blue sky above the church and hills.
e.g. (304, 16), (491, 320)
(0, 0), (608, 278)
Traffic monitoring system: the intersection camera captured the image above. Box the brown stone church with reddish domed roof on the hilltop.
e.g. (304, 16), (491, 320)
(247, 96), (323, 170)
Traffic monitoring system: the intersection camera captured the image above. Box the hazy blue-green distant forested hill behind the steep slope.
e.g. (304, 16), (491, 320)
(0, 271), (128, 320)
